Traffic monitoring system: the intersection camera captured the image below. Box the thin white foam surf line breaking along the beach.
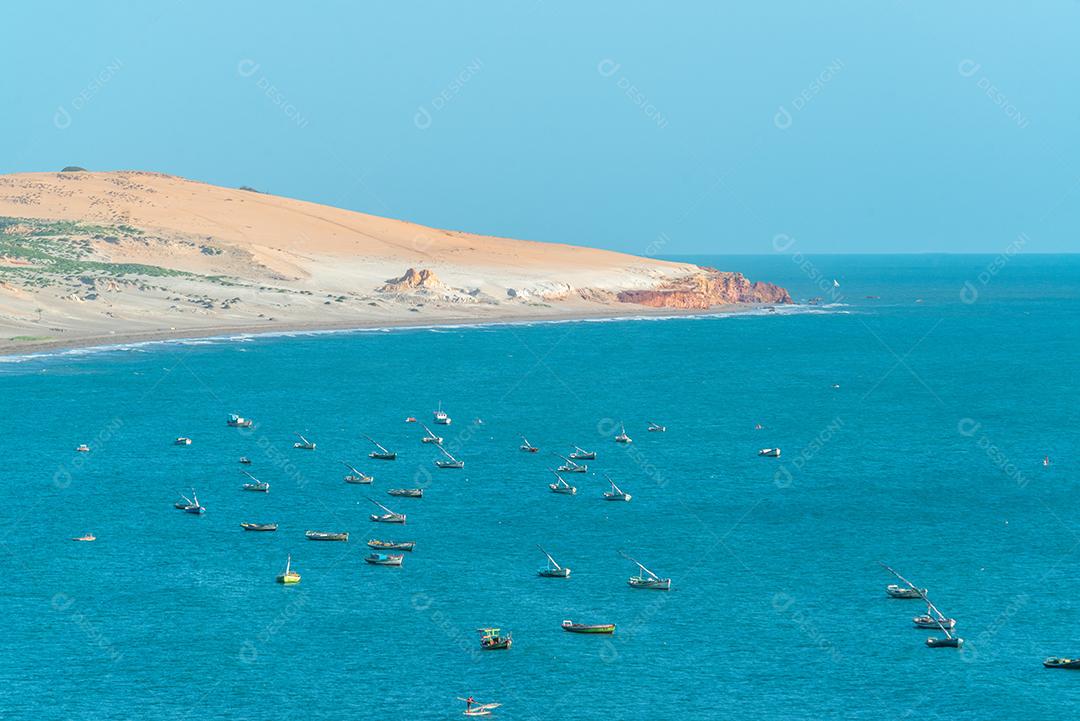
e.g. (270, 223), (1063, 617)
(0, 304), (848, 364)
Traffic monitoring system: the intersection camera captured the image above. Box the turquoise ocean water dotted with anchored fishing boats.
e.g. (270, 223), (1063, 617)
(0, 255), (1080, 721)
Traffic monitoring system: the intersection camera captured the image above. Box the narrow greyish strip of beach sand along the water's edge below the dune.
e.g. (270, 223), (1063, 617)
(0, 303), (774, 358)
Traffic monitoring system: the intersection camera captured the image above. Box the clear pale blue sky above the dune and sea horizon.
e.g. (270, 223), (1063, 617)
(0, 0), (1080, 256)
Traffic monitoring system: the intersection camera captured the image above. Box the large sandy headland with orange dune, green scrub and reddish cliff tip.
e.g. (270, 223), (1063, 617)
(0, 172), (789, 350)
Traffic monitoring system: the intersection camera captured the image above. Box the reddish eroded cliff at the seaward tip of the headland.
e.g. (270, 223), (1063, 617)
(618, 268), (792, 310)
